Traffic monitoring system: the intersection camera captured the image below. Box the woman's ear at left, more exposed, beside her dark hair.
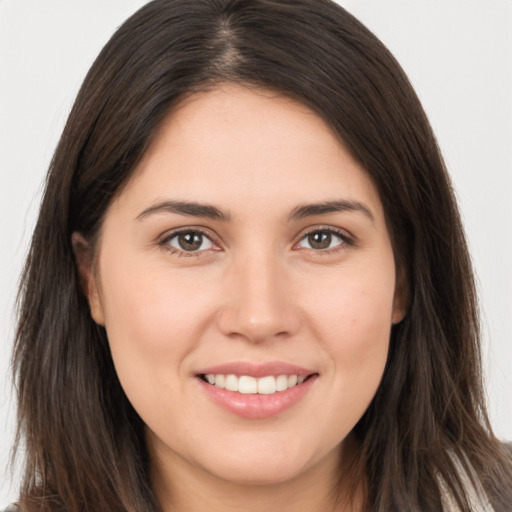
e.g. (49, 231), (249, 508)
(71, 232), (105, 325)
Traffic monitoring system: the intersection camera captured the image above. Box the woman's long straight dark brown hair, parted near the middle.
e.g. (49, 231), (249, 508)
(13, 0), (512, 512)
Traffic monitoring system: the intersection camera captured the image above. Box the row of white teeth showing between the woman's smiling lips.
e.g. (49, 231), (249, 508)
(205, 373), (305, 395)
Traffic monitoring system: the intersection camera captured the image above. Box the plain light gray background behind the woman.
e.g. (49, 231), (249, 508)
(0, 0), (512, 505)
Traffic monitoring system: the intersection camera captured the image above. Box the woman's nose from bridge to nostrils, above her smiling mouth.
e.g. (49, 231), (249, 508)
(217, 254), (300, 343)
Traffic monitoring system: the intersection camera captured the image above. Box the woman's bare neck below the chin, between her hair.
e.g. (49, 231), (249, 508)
(150, 432), (363, 512)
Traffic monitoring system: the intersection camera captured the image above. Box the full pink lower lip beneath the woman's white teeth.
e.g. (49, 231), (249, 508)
(197, 375), (317, 419)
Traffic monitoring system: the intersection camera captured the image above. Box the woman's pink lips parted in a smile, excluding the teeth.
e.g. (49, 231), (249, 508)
(197, 362), (318, 419)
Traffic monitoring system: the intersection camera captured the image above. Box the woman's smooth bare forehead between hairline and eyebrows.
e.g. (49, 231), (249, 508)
(112, 85), (381, 223)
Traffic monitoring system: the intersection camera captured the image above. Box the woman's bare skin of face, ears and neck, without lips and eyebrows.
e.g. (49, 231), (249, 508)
(74, 85), (404, 512)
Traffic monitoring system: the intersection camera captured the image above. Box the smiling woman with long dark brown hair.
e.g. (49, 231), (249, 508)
(8, 0), (512, 512)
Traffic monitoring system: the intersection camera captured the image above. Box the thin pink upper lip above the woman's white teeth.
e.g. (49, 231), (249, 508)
(197, 361), (317, 378)
